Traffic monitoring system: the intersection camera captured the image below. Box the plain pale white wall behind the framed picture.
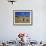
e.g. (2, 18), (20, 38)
(0, 0), (46, 41)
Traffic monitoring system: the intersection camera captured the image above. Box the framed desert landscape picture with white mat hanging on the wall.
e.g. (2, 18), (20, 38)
(13, 10), (32, 25)
